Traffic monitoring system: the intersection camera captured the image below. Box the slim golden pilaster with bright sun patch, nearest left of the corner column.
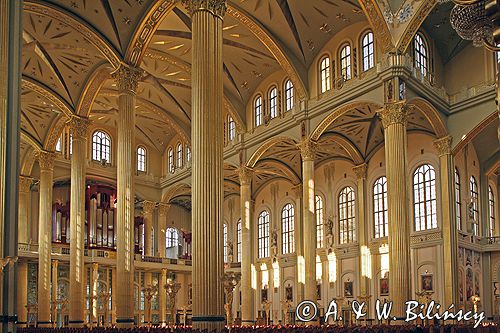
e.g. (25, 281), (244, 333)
(353, 163), (371, 297)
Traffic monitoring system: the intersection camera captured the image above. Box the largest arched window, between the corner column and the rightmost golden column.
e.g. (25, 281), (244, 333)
(413, 164), (437, 231)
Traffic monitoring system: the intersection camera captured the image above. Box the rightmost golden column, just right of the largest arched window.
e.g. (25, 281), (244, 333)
(434, 136), (458, 306)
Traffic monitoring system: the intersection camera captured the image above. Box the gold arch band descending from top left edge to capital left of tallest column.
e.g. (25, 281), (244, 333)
(23, 0), (121, 68)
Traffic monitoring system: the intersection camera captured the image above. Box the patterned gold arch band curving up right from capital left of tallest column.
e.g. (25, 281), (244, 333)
(125, 0), (176, 66)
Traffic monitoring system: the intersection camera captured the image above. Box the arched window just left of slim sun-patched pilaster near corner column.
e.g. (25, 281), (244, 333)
(338, 186), (356, 244)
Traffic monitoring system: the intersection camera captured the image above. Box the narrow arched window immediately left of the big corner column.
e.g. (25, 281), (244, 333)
(373, 176), (389, 238)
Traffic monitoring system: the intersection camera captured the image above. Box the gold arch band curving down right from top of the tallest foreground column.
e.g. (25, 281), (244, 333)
(227, 4), (308, 100)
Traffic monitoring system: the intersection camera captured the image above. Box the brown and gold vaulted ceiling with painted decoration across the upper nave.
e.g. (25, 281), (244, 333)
(21, 0), (450, 156)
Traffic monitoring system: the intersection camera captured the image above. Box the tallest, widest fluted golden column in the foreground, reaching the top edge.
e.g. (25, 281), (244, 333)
(183, 0), (226, 331)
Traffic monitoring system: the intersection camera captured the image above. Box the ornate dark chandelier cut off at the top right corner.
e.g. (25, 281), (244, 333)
(450, 0), (500, 51)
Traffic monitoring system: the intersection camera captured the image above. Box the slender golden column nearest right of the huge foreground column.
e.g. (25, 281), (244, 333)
(238, 166), (255, 325)
